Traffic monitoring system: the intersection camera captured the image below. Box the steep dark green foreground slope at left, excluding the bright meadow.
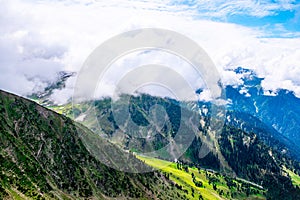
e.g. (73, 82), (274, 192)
(0, 91), (189, 199)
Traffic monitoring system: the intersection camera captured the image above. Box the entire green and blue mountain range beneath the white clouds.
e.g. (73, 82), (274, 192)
(0, 67), (300, 199)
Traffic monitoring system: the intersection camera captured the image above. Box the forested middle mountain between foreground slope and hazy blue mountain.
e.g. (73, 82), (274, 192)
(49, 94), (300, 199)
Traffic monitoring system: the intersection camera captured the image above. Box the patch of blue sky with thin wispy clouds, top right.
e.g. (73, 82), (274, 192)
(170, 0), (300, 37)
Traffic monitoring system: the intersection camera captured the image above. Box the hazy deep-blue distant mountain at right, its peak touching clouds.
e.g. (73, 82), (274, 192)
(226, 67), (300, 160)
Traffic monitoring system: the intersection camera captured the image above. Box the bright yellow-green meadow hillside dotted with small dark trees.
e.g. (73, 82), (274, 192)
(137, 156), (265, 199)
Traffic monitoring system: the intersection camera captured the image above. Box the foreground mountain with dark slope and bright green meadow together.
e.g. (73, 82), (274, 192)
(0, 91), (270, 199)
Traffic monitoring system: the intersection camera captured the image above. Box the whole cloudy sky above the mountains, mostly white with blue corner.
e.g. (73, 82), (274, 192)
(0, 0), (300, 103)
